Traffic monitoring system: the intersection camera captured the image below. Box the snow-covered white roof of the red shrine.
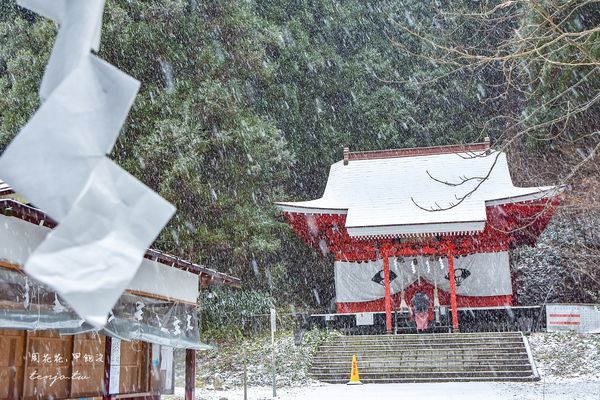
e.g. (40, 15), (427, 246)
(276, 139), (560, 238)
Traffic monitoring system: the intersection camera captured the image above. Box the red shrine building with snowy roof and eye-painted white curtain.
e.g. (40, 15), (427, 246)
(276, 138), (562, 333)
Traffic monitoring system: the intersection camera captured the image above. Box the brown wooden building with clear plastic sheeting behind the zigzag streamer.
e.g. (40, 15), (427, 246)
(0, 181), (241, 400)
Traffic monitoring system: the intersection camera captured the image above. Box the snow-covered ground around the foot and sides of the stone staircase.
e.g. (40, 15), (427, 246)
(165, 333), (600, 400)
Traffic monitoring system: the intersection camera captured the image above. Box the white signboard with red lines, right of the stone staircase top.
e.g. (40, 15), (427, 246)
(546, 304), (600, 333)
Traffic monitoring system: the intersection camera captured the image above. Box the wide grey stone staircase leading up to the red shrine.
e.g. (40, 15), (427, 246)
(311, 332), (539, 383)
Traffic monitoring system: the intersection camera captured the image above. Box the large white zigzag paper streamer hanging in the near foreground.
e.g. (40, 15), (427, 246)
(0, 0), (175, 327)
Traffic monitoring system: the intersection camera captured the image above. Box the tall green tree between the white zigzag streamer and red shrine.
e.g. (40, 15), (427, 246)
(100, 0), (293, 281)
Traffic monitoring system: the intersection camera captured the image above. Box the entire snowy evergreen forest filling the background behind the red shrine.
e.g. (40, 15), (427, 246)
(0, 0), (600, 310)
